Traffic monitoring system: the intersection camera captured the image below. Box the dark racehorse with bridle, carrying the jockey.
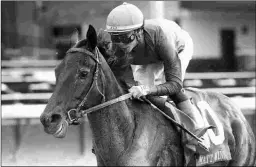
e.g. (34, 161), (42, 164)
(40, 25), (255, 166)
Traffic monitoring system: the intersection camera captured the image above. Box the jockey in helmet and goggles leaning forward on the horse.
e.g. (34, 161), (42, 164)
(106, 3), (211, 151)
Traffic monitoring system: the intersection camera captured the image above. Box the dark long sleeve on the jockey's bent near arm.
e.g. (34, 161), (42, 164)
(149, 27), (182, 96)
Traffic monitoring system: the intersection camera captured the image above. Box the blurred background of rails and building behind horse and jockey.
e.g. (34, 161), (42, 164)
(1, 1), (256, 166)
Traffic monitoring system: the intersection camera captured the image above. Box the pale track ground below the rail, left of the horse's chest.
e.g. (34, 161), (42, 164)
(1, 124), (96, 166)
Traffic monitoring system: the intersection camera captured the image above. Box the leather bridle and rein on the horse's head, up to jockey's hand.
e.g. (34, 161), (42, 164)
(67, 47), (132, 125)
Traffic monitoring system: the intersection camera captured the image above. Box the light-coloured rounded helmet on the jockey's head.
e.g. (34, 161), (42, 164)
(106, 2), (144, 33)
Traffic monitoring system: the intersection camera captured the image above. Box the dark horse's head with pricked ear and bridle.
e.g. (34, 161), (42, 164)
(40, 25), (108, 137)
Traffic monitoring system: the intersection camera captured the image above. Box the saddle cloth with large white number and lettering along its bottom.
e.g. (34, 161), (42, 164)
(148, 97), (231, 166)
